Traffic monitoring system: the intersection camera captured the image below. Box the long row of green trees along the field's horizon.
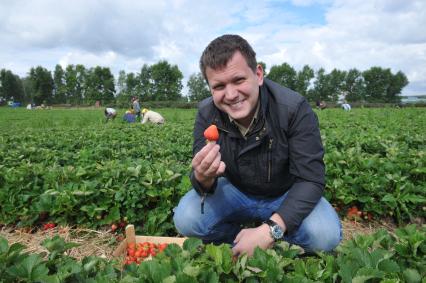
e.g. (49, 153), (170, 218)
(0, 61), (408, 106)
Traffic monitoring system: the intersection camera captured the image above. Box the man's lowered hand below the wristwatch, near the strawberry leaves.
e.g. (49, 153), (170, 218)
(232, 224), (274, 256)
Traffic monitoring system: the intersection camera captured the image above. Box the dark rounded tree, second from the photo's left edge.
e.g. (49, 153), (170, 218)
(29, 66), (54, 104)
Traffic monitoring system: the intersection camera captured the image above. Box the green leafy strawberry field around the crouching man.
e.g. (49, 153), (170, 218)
(0, 108), (426, 282)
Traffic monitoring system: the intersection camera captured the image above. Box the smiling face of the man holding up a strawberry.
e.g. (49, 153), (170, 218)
(206, 51), (263, 127)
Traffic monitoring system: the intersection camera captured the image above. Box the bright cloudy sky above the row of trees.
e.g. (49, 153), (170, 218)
(0, 0), (426, 95)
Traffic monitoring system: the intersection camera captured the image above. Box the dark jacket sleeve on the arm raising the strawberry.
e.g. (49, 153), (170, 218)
(189, 103), (217, 194)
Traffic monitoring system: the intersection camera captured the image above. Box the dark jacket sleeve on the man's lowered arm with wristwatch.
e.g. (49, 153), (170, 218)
(277, 100), (325, 234)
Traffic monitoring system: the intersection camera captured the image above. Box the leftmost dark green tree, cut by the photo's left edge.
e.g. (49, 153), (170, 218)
(0, 69), (25, 102)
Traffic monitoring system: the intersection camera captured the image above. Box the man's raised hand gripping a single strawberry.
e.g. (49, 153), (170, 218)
(192, 142), (226, 190)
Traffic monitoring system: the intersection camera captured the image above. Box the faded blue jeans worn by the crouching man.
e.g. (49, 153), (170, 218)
(173, 178), (342, 252)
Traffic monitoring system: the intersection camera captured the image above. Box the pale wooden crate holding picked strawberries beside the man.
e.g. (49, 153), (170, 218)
(112, 224), (186, 257)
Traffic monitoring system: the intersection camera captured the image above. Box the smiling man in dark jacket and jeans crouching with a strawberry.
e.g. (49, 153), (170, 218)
(174, 35), (341, 255)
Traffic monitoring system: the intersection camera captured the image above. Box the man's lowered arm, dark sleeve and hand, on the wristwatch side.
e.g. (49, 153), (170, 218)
(232, 101), (325, 255)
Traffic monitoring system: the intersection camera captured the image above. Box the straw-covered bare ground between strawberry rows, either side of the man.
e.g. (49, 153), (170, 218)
(0, 220), (396, 260)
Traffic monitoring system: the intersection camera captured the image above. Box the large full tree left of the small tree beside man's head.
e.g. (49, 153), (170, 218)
(151, 61), (183, 101)
